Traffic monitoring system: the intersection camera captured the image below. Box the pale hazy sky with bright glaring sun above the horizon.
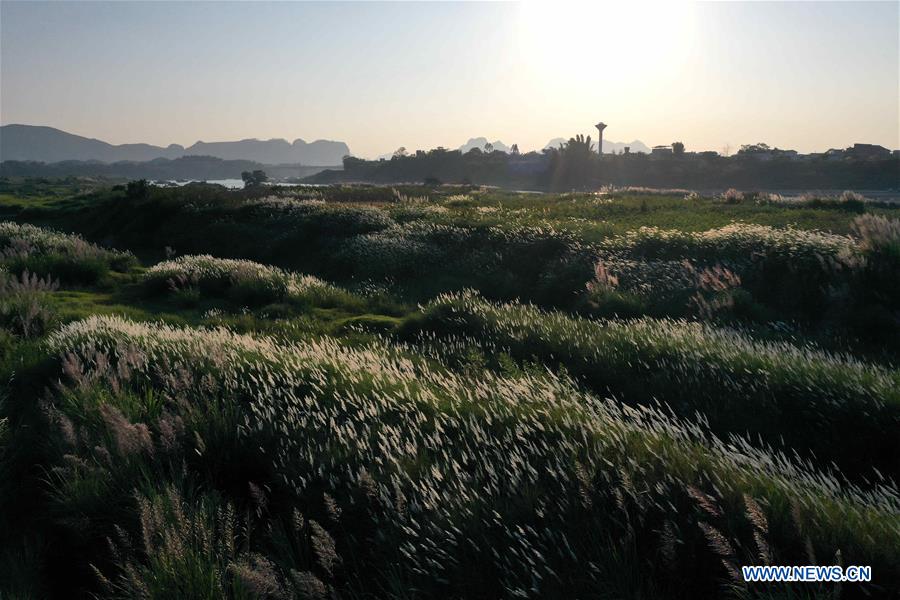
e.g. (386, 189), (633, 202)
(0, 0), (900, 156)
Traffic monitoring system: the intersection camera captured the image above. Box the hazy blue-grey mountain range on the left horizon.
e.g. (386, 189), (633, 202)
(0, 125), (350, 166)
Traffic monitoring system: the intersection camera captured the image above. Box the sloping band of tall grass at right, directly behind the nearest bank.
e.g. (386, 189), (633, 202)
(420, 293), (900, 477)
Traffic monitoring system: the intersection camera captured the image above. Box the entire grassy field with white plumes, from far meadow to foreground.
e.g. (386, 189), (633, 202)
(0, 182), (900, 599)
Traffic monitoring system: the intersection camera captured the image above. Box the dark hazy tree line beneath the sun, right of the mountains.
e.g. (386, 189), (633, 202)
(309, 135), (900, 191)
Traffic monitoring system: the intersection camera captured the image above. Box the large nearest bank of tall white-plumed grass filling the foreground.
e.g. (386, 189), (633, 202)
(1, 317), (884, 597)
